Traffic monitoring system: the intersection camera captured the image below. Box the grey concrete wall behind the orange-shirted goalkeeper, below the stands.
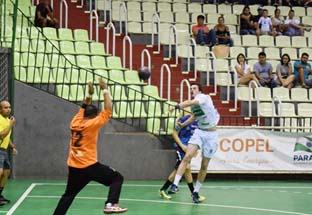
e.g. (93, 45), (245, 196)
(13, 82), (175, 179)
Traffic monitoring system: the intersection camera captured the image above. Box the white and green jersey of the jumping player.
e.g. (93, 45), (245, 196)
(191, 93), (220, 129)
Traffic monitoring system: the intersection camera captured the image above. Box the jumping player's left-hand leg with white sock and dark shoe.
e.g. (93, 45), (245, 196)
(170, 144), (198, 193)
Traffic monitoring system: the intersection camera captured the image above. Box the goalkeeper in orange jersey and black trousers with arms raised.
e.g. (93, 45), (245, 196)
(53, 79), (128, 215)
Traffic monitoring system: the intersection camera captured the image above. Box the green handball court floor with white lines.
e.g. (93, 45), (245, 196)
(0, 180), (312, 215)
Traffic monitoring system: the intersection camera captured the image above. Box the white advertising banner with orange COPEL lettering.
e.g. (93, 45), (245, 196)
(191, 129), (312, 173)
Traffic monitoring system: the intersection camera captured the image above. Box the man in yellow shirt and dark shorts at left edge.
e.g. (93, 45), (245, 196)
(0, 101), (17, 206)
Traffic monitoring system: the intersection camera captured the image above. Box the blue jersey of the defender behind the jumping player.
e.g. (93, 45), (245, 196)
(174, 115), (198, 147)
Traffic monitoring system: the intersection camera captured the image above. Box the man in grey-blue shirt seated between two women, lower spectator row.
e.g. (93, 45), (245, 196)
(253, 52), (277, 88)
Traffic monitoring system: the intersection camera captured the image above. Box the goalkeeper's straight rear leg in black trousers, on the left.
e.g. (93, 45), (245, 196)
(53, 167), (90, 215)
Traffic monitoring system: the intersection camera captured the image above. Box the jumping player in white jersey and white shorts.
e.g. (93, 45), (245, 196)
(170, 83), (220, 203)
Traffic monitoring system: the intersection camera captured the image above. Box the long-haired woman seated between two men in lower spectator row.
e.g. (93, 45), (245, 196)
(276, 54), (295, 89)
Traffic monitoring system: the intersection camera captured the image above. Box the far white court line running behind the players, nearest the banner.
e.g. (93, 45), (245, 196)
(36, 183), (312, 189)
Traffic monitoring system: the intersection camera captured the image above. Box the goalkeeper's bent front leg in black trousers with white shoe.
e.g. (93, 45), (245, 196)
(88, 163), (128, 214)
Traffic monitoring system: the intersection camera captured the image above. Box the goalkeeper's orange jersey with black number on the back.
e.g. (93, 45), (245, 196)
(67, 108), (112, 168)
